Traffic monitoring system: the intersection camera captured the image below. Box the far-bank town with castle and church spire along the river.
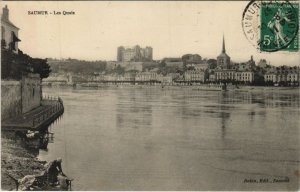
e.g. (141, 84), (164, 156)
(62, 37), (299, 85)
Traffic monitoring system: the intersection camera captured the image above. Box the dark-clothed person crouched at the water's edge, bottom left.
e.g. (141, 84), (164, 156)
(46, 158), (65, 184)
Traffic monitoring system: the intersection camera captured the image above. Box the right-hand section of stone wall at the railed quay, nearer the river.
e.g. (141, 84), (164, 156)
(21, 74), (41, 113)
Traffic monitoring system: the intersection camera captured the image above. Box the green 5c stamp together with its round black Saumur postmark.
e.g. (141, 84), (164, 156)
(242, 0), (299, 52)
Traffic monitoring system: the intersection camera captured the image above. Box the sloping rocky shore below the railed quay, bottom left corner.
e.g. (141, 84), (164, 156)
(1, 133), (46, 190)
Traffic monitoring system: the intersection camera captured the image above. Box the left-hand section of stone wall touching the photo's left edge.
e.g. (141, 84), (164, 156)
(1, 80), (22, 120)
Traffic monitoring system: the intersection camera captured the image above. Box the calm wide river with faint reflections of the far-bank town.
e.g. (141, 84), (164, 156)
(39, 87), (300, 190)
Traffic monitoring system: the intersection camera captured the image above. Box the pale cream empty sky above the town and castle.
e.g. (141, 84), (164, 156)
(1, 1), (300, 66)
